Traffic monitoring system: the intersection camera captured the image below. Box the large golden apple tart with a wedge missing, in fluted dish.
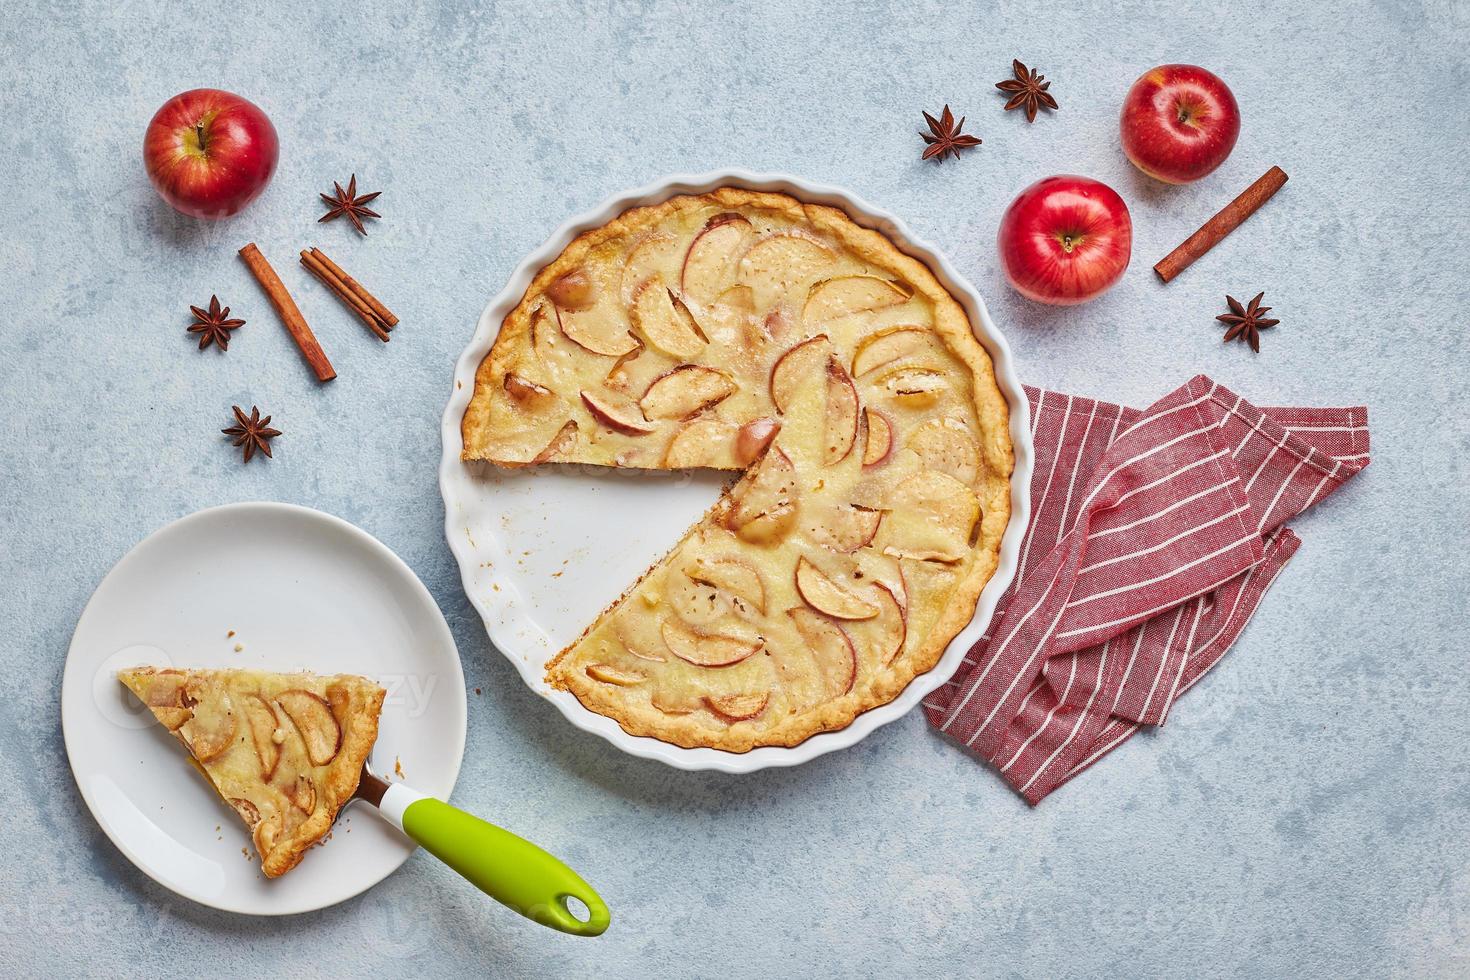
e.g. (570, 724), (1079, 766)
(463, 188), (1013, 752)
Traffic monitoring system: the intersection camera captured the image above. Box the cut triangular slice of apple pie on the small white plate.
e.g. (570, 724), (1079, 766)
(118, 667), (387, 877)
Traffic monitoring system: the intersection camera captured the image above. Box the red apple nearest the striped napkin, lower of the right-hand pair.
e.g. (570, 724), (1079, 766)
(997, 175), (1133, 306)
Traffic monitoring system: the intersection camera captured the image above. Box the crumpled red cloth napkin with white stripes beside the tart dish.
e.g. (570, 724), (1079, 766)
(925, 375), (1369, 805)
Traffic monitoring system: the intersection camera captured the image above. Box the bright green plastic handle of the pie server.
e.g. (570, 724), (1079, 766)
(403, 799), (612, 936)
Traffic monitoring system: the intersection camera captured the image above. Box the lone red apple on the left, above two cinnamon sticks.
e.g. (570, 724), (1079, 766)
(143, 88), (281, 217)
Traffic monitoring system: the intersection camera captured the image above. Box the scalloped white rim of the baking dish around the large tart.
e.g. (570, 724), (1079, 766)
(440, 169), (1033, 773)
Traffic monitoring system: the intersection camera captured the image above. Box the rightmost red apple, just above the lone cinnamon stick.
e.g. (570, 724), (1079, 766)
(1120, 65), (1241, 184)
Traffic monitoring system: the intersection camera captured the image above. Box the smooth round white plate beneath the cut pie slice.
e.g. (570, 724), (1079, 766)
(62, 502), (465, 915)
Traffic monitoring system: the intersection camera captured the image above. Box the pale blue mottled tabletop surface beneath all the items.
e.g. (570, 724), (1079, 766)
(0, 0), (1470, 977)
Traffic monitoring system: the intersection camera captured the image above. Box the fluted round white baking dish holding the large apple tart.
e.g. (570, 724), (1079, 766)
(440, 170), (1032, 773)
